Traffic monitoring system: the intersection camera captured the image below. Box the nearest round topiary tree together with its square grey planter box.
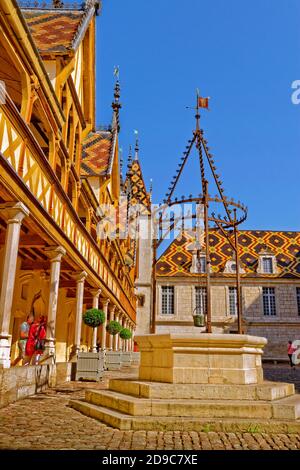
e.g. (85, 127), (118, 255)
(76, 308), (105, 381)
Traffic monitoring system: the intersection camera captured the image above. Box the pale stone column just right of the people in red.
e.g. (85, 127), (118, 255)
(45, 246), (66, 356)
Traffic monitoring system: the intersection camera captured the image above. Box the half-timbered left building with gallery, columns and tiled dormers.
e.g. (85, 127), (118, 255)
(0, 0), (136, 367)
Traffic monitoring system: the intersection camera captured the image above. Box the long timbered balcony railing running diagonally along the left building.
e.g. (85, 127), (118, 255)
(0, 95), (135, 317)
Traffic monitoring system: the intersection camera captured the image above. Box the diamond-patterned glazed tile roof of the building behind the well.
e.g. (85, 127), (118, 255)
(156, 229), (300, 279)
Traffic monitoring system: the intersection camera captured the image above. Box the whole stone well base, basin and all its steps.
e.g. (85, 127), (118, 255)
(70, 333), (300, 432)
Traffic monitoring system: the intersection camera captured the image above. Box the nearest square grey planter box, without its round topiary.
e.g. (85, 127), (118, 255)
(75, 351), (104, 381)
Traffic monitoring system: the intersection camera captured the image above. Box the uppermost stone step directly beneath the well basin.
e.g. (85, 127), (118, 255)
(109, 379), (295, 401)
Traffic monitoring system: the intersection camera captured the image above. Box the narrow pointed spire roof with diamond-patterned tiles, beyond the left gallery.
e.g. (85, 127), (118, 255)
(125, 160), (151, 209)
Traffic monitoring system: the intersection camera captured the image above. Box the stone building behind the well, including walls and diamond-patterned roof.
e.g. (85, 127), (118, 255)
(150, 230), (300, 359)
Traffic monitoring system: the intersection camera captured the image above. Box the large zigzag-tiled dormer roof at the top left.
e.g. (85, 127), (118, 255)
(22, 10), (84, 53)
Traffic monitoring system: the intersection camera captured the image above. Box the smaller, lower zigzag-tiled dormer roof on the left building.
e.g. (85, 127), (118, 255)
(81, 131), (112, 176)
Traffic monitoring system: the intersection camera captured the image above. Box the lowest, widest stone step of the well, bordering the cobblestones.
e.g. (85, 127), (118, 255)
(70, 400), (300, 433)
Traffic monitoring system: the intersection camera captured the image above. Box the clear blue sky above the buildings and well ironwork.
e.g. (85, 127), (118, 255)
(96, 0), (300, 230)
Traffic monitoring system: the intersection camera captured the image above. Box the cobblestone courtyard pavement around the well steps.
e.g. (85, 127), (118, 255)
(0, 366), (300, 450)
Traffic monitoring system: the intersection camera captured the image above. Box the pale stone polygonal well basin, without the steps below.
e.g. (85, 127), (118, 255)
(135, 333), (267, 384)
